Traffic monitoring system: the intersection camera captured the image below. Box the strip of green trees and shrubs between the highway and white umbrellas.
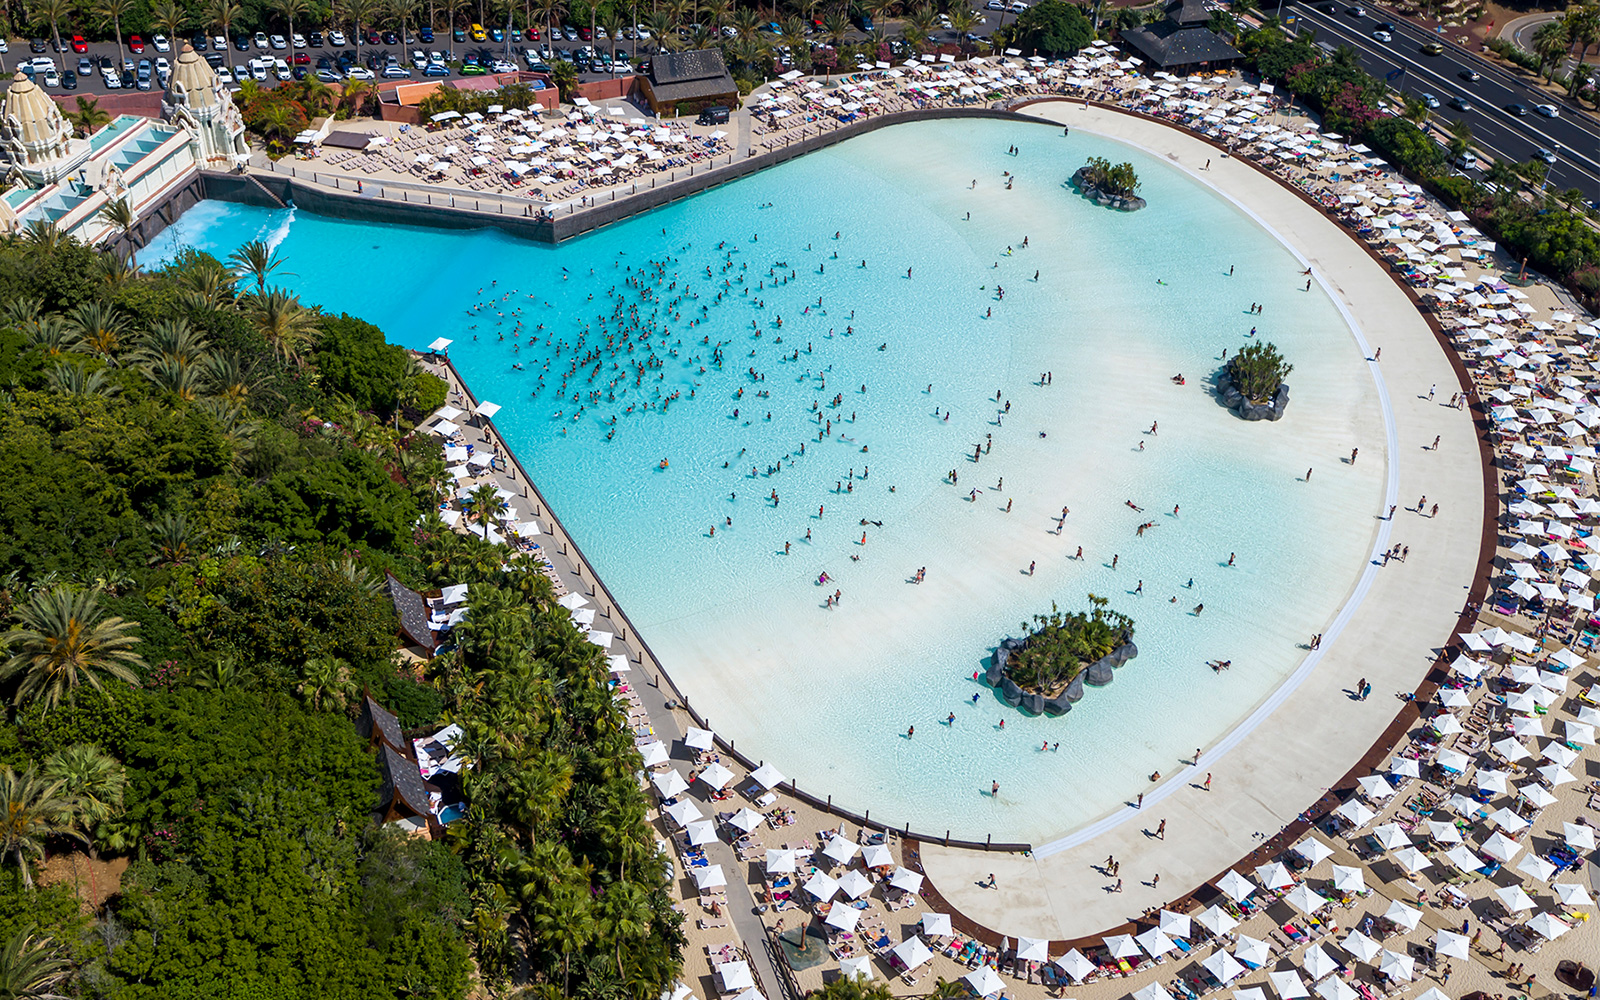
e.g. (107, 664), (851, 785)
(1238, 19), (1600, 309)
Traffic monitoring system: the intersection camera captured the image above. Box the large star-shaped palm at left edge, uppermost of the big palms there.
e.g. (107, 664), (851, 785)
(0, 586), (144, 712)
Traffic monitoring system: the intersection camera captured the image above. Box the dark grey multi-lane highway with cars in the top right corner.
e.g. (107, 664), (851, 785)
(1282, 0), (1600, 200)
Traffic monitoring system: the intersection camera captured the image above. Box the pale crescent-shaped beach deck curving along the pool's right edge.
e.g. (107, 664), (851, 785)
(922, 101), (1485, 939)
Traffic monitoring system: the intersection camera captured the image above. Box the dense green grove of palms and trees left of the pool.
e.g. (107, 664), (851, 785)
(0, 226), (682, 1000)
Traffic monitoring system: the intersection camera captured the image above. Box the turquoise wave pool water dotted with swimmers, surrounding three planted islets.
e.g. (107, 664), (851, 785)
(142, 122), (1384, 843)
